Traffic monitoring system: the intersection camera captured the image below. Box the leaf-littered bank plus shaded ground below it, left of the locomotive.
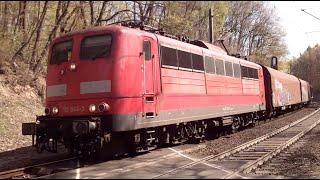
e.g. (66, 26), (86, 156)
(0, 79), (66, 172)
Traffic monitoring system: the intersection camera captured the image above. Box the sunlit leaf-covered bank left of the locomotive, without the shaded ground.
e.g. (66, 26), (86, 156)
(0, 83), (44, 152)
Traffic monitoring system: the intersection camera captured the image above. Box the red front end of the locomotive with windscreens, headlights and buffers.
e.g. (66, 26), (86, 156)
(22, 26), (140, 154)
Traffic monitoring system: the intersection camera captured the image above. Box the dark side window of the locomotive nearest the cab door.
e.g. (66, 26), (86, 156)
(160, 46), (178, 67)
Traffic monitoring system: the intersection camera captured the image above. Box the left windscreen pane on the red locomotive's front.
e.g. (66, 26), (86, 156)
(50, 41), (73, 64)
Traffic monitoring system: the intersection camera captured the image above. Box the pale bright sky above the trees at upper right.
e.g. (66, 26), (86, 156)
(269, 1), (320, 59)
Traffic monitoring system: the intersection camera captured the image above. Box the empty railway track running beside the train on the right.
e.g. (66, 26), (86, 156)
(152, 109), (320, 179)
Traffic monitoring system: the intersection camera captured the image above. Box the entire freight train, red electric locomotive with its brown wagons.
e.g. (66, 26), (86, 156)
(22, 21), (312, 154)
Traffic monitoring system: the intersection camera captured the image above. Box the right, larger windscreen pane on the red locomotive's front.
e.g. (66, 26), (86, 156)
(80, 35), (112, 60)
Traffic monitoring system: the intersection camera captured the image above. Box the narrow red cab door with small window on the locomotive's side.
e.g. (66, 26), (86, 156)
(141, 37), (156, 118)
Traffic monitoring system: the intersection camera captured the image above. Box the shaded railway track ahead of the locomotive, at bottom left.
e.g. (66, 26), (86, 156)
(0, 157), (78, 179)
